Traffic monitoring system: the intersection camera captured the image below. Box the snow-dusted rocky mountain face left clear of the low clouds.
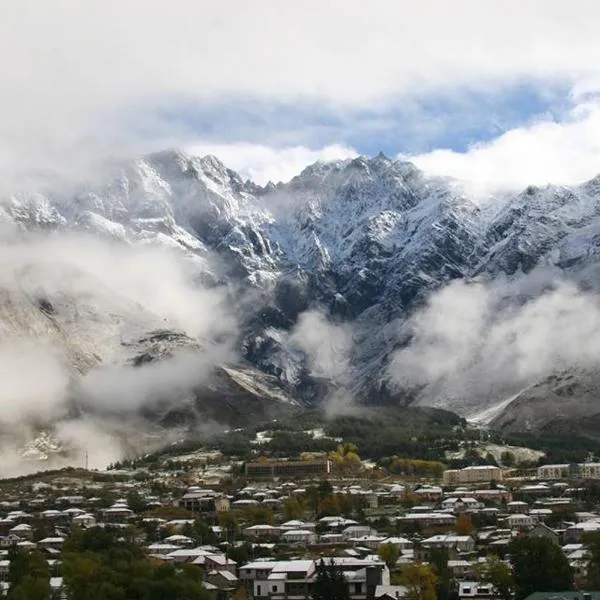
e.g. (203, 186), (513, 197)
(0, 150), (600, 434)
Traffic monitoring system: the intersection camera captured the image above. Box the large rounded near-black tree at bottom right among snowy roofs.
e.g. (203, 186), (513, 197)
(509, 537), (573, 600)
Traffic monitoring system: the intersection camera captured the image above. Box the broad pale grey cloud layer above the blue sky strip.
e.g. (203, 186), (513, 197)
(0, 0), (600, 189)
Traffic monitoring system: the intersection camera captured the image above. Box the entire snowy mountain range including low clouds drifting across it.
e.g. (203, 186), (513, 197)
(0, 150), (600, 460)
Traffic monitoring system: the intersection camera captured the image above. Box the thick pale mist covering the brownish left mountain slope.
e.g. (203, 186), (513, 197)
(0, 231), (237, 475)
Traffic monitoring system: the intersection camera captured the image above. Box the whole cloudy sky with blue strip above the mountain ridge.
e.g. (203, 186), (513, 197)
(0, 0), (600, 189)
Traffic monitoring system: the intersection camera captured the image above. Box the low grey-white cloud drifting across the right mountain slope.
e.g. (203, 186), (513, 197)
(389, 272), (600, 413)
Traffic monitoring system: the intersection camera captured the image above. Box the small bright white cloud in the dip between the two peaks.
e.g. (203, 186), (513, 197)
(187, 143), (358, 185)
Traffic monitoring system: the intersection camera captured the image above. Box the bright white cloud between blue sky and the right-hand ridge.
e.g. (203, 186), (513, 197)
(410, 92), (600, 194)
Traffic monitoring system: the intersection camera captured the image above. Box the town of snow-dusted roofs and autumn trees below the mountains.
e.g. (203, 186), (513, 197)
(0, 432), (600, 600)
